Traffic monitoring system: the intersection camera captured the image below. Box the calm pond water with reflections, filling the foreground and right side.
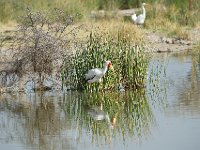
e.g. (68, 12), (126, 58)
(0, 54), (200, 150)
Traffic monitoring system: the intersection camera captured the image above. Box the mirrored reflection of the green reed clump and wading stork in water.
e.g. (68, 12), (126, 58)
(65, 91), (155, 143)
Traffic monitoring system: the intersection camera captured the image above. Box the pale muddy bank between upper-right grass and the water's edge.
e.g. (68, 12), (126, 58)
(145, 29), (200, 53)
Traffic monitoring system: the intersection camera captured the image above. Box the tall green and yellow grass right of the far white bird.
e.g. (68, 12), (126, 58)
(145, 0), (200, 39)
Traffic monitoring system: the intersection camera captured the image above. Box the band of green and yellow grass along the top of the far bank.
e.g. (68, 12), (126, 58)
(0, 0), (200, 43)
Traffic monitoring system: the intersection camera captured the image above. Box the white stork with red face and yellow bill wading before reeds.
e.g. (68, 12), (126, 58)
(85, 60), (113, 83)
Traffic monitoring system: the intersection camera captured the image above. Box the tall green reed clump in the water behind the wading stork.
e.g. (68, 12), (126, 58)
(63, 27), (147, 91)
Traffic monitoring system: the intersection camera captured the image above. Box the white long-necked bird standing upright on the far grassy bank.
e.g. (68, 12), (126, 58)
(131, 3), (146, 25)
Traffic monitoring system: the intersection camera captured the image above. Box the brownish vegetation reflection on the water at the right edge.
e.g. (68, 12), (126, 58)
(175, 54), (200, 114)
